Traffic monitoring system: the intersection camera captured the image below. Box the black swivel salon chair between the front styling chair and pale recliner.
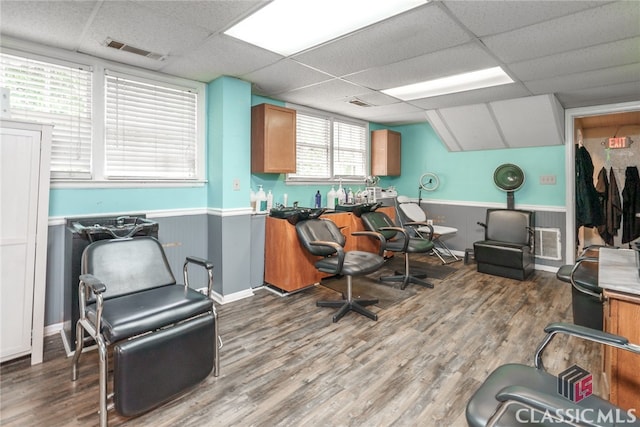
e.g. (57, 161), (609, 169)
(360, 211), (434, 289)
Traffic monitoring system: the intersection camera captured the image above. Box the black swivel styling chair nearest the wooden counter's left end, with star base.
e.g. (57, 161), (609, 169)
(296, 218), (385, 323)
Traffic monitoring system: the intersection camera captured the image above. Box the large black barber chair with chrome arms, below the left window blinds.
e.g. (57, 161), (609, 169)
(72, 237), (219, 427)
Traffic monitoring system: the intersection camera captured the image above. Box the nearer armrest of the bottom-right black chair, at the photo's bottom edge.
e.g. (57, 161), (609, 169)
(487, 386), (602, 427)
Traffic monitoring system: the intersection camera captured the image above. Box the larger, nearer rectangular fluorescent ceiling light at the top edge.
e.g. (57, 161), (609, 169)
(225, 0), (429, 56)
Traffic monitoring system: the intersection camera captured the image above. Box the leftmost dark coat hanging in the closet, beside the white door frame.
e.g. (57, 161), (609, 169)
(576, 146), (604, 227)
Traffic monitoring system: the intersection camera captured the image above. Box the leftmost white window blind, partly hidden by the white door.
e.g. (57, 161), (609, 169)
(0, 53), (92, 178)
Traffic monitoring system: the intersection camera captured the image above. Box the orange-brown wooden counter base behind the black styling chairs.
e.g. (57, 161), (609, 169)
(264, 207), (395, 292)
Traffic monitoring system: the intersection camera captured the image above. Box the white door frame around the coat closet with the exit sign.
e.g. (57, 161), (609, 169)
(564, 101), (640, 264)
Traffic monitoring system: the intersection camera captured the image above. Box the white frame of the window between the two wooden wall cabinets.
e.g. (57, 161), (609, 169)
(285, 103), (371, 185)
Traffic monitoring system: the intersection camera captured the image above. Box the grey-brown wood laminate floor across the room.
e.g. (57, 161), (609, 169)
(0, 259), (601, 427)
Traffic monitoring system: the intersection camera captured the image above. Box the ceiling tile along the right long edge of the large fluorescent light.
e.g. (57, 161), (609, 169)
(294, 3), (470, 76)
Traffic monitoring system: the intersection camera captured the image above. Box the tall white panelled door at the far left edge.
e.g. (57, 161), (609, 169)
(0, 128), (41, 361)
